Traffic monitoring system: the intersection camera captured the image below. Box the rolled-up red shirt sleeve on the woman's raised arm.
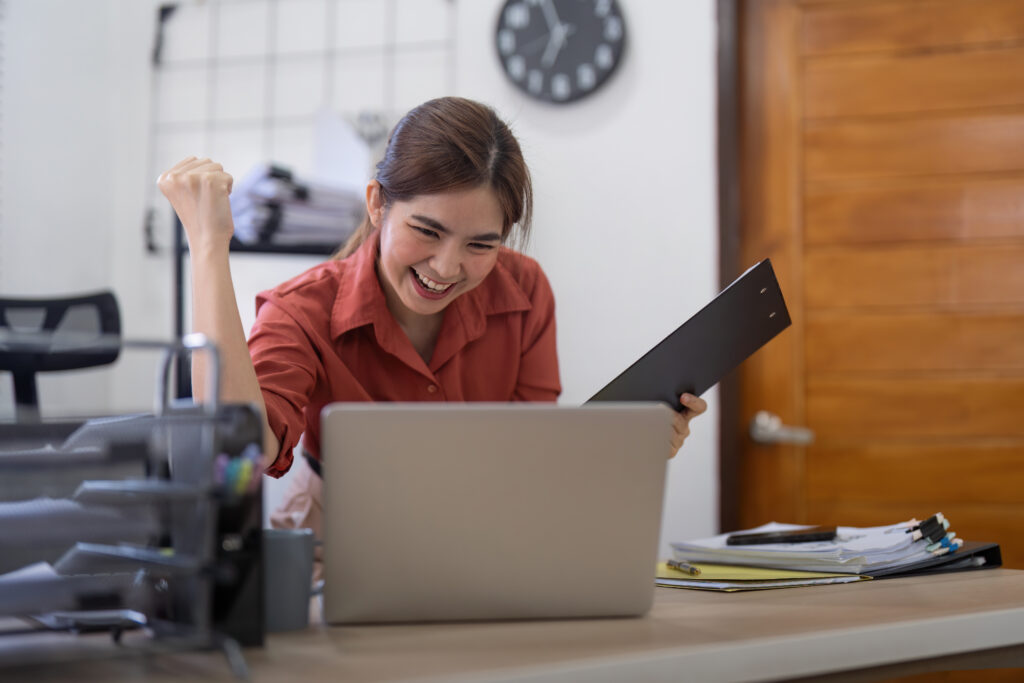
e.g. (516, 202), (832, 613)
(249, 293), (323, 477)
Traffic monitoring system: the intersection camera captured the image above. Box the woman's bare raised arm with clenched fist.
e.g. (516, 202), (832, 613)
(158, 157), (279, 469)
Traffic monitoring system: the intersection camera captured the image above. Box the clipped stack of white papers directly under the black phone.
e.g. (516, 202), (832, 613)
(672, 515), (958, 574)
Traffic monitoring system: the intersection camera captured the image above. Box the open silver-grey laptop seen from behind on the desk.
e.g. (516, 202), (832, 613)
(321, 402), (674, 624)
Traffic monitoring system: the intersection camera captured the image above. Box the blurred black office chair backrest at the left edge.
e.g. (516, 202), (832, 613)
(0, 292), (121, 422)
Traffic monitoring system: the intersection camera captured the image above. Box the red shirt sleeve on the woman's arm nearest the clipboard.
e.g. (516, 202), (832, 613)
(512, 260), (562, 401)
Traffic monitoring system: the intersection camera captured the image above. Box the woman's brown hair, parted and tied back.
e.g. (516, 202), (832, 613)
(334, 97), (534, 259)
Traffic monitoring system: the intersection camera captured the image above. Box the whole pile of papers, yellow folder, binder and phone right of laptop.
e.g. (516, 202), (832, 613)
(656, 513), (1002, 590)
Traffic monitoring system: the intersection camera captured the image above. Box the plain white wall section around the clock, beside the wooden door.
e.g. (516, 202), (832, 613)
(456, 0), (718, 552)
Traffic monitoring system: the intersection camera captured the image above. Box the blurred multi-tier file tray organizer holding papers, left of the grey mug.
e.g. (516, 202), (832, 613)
(0, 336), (263, 678)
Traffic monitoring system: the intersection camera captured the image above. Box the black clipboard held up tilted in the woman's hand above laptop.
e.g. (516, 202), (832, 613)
(587, 258), (792, 411)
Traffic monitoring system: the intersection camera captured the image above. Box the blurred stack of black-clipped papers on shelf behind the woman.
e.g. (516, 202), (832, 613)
(231, 164), (366, 246)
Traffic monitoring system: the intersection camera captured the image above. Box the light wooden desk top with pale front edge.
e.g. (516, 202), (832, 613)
(0, 569), (1024, 683)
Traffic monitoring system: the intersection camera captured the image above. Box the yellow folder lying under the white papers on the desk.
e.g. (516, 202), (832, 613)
(654, 562), (870, 593)
